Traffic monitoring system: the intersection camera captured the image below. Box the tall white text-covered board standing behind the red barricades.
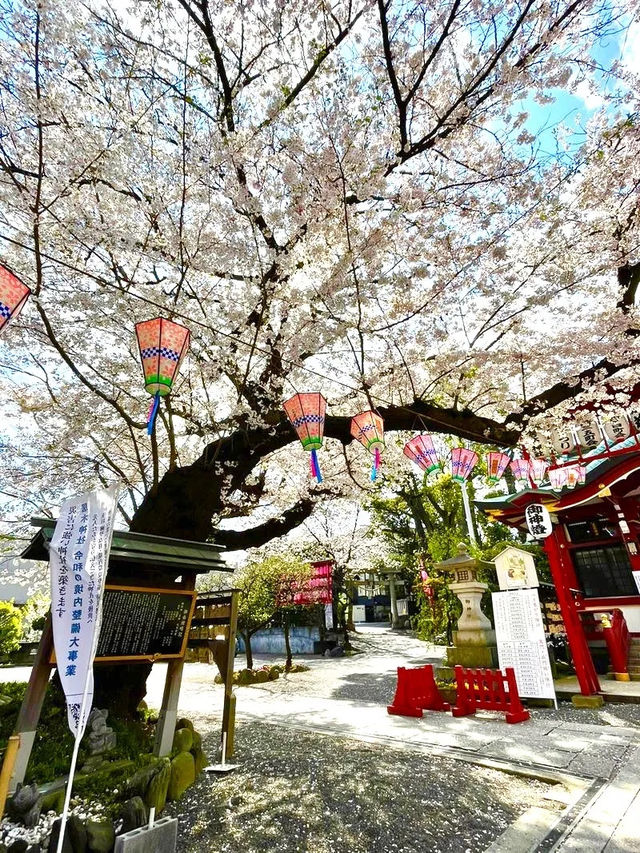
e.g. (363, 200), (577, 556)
(491, 589), (556, 700)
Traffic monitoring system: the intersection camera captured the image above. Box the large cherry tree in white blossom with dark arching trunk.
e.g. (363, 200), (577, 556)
(0, 0), (640, 549)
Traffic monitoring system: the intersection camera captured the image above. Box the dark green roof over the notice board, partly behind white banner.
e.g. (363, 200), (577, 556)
(22, 518), (233, 574)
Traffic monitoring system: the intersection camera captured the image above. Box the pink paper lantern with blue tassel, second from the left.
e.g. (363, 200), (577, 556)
(136, 317), (191, 435)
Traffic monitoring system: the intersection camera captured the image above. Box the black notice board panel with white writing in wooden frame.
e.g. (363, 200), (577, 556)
(96, 586), (196, 661)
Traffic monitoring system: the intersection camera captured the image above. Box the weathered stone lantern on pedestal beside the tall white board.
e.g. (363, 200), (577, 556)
(434, 543), (498, 676)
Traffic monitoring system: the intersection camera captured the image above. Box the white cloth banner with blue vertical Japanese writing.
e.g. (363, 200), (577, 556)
(49, 486), (116, 738)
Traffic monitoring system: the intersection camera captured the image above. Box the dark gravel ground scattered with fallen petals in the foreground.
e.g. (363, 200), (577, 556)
(165, 718), (559, 853)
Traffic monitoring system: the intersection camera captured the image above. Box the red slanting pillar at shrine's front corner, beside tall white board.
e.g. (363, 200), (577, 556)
(544, 525), (600, 696)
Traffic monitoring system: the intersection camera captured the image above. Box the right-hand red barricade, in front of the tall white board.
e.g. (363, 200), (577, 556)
(451, 666), (529, 723)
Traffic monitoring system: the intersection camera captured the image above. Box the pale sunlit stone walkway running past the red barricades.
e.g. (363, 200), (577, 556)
(136, 627), (640, 853)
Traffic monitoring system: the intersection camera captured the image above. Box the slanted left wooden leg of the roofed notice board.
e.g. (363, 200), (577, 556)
(7, 613), (53, 792)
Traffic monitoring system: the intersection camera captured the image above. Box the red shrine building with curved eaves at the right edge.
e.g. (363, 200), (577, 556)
(476, 450), (640, 695)
